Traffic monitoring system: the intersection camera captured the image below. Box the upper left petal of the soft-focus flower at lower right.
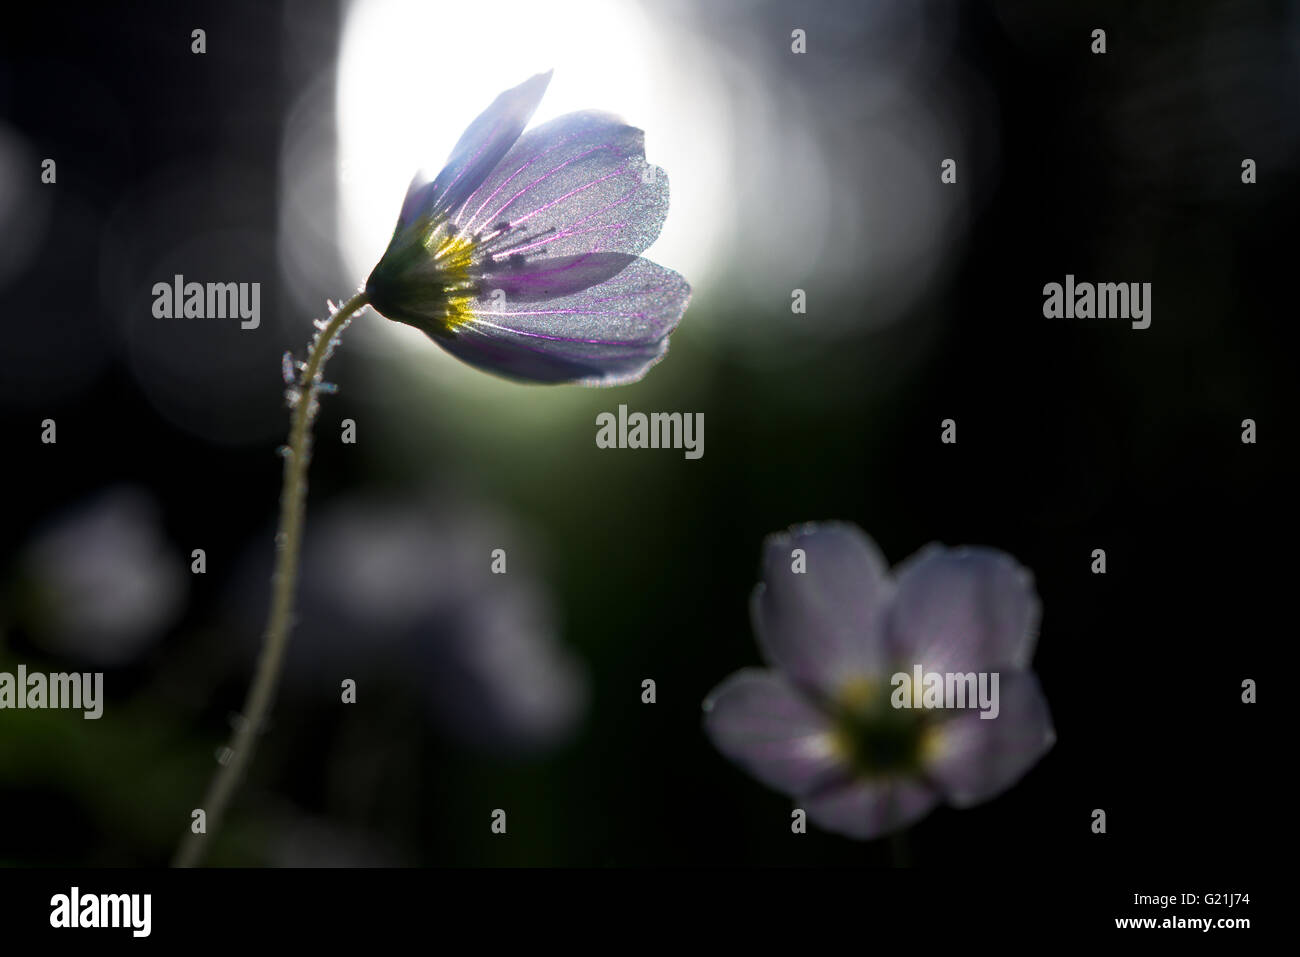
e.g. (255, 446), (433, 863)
(750, 521), (893, 698)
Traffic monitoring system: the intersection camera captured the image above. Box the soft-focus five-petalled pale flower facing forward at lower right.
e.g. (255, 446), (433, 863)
(705, 523), (1056, 839)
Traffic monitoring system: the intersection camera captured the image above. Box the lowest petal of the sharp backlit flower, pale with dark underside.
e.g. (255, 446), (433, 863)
(436, 259), (690, 386)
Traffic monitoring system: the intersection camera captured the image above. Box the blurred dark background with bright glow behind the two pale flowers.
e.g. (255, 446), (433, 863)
(0, 0), (1279, 865)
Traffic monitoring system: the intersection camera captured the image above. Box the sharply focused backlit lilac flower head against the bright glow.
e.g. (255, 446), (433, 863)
(365, 73), (690, 386)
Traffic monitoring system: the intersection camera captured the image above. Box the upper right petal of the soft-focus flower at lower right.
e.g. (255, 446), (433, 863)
(888, 545), (1039, 672)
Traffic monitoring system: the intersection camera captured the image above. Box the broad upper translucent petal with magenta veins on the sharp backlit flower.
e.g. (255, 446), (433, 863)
(452, 112), (668, 257)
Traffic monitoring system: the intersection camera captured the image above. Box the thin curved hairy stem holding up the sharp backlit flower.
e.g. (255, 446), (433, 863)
(173, 293), (367, 867)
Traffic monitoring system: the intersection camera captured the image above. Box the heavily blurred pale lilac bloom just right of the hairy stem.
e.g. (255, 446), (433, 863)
(233, 497), (588, 753)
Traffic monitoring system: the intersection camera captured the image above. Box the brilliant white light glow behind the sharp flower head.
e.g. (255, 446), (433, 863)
(338, 0), (732, 299)
